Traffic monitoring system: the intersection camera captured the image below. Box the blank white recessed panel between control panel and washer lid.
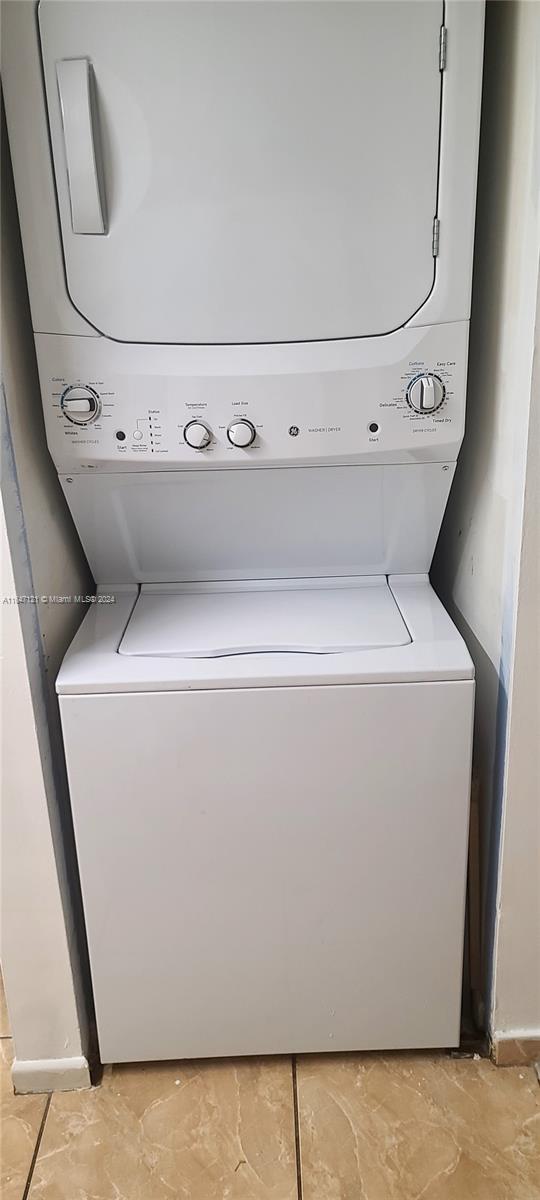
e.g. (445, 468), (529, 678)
(60, 463), (455, 583)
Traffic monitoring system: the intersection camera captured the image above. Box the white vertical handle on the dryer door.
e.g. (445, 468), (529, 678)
(56, 59), (107, 234)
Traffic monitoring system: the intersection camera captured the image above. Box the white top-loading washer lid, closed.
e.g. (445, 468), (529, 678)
(119, 576), (410, 659)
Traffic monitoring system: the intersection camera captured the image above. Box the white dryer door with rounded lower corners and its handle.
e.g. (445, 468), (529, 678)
(40, 0), (443, 343)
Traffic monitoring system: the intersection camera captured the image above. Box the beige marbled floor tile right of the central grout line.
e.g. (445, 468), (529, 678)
(298, 1055), (540, 1200)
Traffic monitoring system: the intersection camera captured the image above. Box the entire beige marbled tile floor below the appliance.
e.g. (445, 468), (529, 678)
(0, 974), (540, 1200)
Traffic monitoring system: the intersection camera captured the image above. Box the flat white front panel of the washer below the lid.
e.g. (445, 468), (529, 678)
(60, 682), (474, 1062)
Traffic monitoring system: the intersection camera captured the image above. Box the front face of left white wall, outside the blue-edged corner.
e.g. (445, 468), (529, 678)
(1, 508), (89, 1090)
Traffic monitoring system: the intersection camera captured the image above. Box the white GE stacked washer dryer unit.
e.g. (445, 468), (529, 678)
(5, 0), (484, 1062)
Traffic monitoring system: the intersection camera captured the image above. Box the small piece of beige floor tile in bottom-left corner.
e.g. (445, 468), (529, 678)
(0, 1038), (47, 1200)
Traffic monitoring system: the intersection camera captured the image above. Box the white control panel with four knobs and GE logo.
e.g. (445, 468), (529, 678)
(36, 322), (468, 472)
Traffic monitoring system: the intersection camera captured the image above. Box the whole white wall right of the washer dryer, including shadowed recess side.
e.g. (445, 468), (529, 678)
(433, 0), (540, 1036)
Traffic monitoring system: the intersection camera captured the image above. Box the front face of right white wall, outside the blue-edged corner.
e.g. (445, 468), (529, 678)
(491, 304), (540, 1040)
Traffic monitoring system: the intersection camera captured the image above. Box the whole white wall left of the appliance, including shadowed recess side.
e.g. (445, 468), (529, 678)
(1, 110), (92, 1090)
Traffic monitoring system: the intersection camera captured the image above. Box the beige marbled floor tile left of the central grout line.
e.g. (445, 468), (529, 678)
(30, 1058), (296, 1200)
